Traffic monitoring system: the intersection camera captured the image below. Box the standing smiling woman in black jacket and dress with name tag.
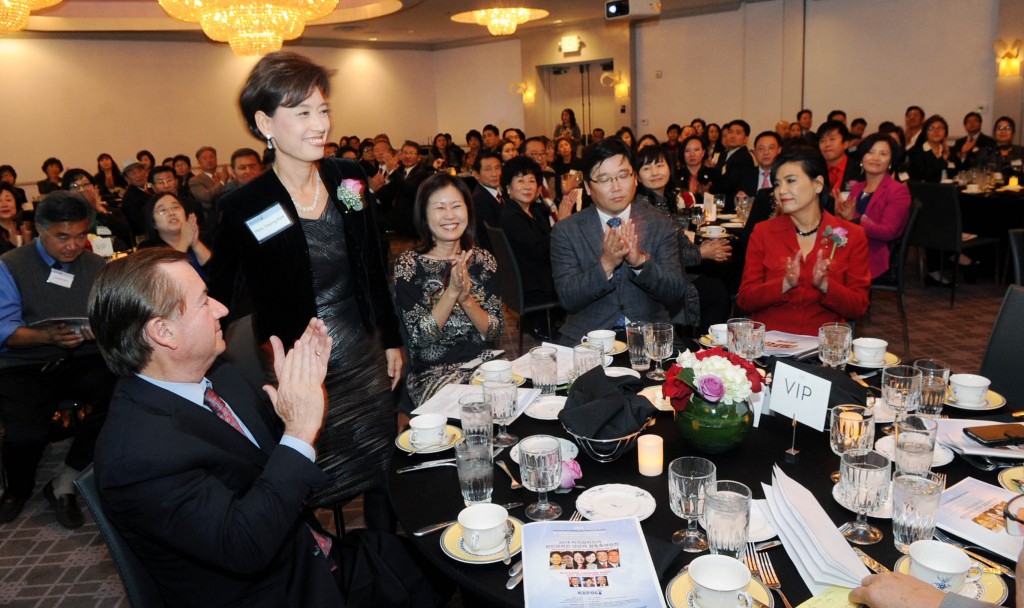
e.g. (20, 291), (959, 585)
(210, 52), (403, 529)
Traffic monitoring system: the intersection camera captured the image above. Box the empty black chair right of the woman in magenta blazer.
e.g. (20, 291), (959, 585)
(909, 182), (999, 308)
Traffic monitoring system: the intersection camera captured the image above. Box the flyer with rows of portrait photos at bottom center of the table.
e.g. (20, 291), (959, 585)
(522, 518), (665, 608)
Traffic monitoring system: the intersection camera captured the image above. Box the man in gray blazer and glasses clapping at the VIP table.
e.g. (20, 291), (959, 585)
(551, 139), (687, 345)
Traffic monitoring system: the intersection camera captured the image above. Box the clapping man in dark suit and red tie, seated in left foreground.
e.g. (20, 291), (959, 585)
(89, 248), (444, 608)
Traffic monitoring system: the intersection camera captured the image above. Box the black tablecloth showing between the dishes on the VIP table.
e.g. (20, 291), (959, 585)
(389, 355), (1014, 606)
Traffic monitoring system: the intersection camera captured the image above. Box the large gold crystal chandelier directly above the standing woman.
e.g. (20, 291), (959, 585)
(157, 0), (338, 55)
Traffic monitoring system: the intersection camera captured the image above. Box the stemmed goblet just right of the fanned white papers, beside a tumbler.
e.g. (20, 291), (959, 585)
(839, 449), (891, 545)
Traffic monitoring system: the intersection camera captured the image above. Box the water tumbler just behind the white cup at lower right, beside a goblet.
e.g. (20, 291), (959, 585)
(893, 473), (943, 554)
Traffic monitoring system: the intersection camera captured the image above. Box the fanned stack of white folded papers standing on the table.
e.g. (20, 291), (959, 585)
(761, 466), (870, 595)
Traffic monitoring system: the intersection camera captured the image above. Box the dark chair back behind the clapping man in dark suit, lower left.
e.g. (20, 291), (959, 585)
(75, 465), (164, 608)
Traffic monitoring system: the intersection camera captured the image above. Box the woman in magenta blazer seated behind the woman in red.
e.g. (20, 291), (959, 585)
(836, 133), (910, 283)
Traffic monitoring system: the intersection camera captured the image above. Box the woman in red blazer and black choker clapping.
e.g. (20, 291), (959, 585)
(736, 148), (870, 336)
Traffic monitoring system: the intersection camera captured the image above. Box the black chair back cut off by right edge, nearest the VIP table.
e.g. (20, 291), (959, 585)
(979, 285), (1024, 405)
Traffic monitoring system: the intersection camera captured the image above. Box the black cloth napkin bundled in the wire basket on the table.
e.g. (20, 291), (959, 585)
(558, 366), (657, 439)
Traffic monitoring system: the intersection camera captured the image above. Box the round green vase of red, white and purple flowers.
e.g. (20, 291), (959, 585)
(662, 348), (763, 453)
